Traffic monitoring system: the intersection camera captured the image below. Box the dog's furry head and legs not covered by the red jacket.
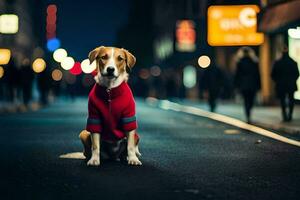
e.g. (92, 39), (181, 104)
(79, 46), (142, 166)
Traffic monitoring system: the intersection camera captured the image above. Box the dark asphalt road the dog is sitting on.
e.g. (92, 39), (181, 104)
(0, 100), (300, 200)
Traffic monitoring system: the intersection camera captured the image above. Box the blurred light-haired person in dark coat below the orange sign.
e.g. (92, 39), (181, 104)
(234, 47), (260, 123)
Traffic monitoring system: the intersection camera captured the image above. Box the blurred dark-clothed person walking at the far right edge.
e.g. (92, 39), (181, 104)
(271, 47), (299, 122)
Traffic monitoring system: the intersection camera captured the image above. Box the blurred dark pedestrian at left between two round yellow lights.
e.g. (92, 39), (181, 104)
(21, 58), (34, 108)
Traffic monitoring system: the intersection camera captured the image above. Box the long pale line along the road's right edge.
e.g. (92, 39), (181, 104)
(158, 100), (300, 147)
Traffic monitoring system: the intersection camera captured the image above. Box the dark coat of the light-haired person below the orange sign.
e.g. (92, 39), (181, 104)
(234, 56), (260, 92)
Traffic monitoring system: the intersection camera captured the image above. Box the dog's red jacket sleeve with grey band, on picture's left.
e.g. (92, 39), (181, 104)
(86, 99), (102, 133)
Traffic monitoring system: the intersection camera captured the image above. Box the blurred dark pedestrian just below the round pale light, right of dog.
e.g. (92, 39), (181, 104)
(200, 62), (224, 112)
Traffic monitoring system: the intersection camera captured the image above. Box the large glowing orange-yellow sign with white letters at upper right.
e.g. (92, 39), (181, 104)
(207, 5), (264, 46)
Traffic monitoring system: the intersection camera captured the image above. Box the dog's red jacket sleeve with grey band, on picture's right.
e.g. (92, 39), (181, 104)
(122, 98), (137, 131)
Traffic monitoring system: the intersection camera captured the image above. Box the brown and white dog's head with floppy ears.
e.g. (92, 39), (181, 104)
(89, 46), (136, 79)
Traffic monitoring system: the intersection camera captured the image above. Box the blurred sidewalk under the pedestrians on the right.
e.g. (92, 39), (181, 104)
(181, 100), (300, 135)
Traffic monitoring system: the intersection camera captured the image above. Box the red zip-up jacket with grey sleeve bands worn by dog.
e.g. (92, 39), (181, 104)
(86, 82), (138, 141)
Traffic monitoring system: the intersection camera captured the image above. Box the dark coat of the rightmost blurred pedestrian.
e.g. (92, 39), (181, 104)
(271, 53), (299, 94)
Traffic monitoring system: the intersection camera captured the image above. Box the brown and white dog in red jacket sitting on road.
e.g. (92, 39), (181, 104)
(79, 46), (142, 166)
